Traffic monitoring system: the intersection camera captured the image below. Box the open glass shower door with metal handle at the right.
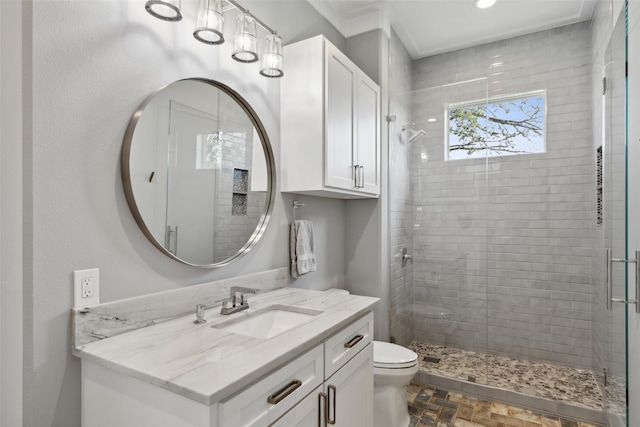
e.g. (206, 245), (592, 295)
(594, 2), (637, 427)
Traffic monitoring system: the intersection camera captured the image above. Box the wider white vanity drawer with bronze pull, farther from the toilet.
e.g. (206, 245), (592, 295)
(218, 345), (323, 427)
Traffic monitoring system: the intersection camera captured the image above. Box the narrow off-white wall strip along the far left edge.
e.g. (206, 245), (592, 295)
(0, 1), (23, 426)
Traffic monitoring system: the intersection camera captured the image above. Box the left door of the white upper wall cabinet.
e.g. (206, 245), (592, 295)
(325, 44), (357, 190)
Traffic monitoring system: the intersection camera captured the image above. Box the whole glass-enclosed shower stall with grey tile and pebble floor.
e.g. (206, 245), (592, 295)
(389, 5), (627, 426)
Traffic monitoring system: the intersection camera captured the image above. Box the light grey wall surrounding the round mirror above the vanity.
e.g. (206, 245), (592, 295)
(23, 0), (345, 427)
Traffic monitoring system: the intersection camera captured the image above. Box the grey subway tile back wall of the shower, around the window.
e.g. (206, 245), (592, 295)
(410, 22), (596, 367)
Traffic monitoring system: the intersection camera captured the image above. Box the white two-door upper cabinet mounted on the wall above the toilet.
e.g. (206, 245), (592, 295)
(280, 36), (380, 199)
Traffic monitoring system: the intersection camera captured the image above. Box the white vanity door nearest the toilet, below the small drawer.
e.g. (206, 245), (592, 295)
(324, 344), (373, 427)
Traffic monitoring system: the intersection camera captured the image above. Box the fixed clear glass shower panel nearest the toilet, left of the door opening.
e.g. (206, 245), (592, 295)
(400, 78), (488, 384)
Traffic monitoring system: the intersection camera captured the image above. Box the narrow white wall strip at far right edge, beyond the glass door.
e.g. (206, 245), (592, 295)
(627, 1), (640, 426)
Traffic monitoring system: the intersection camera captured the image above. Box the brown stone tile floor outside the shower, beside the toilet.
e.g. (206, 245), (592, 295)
(407, 384), (595, 427)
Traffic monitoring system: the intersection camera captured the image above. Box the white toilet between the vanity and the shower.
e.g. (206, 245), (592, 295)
(373, 341), (418, 427)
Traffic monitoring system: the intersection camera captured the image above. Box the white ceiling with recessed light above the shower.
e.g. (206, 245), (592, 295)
(308, 0), (597, 59)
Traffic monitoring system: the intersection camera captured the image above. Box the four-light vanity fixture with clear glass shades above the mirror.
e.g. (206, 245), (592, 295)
(145, 0), (284, 77)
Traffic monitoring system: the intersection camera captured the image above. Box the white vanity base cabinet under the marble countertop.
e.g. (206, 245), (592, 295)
(82, 312), (373, 427)
